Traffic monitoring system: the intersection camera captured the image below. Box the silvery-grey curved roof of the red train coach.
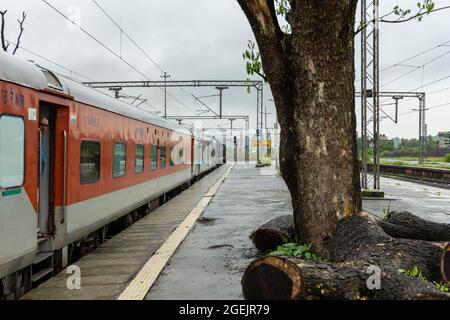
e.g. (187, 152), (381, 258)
(0, 50), (192, 135)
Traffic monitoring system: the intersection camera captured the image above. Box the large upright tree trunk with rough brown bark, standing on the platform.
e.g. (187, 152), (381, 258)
(238, 0), (361, 256)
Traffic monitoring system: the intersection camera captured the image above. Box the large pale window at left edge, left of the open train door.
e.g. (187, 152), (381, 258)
(0, 115), (25, 189)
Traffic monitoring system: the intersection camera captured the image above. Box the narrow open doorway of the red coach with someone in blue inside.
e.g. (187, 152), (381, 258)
(38, 104), (56, 238)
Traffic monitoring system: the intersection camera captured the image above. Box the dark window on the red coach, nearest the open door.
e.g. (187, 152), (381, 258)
(80, 141), (100, 184)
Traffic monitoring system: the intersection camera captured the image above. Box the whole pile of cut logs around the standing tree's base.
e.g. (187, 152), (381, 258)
(242, 212), (450, 300)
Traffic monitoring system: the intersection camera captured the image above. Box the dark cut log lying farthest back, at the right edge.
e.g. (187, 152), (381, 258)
(380, 211), (450, 242)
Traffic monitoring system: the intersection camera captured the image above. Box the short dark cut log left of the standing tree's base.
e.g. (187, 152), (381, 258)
(250, 215), (295, 252)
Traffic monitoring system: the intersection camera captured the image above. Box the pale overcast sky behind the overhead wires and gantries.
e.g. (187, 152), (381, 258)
(0, 0), (450, 137)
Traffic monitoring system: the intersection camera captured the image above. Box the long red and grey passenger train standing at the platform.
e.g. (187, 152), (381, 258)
(0, 52), (226, 299)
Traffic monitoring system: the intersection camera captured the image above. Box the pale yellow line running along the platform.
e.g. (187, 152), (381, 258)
(117, 164), (234, 300)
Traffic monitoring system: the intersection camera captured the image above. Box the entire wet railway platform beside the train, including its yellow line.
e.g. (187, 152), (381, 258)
(20, 164), (450, 300)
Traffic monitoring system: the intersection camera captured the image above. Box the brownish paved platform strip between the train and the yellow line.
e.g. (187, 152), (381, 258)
(23, 165), (228, 300)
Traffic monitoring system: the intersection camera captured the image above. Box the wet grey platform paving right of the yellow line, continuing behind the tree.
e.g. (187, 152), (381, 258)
(146, 164), (450, 300)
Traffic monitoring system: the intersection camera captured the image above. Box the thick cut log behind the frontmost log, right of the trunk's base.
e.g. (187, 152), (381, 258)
(330, 215), (445, 282)
